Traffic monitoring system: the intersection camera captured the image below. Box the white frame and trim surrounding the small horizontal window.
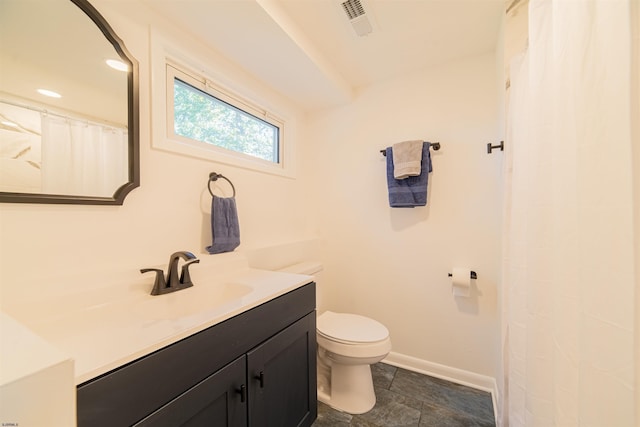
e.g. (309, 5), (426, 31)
(149, 27), (301, 179)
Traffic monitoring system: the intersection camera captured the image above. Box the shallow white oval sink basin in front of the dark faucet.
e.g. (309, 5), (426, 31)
(134, 283), (253, 320)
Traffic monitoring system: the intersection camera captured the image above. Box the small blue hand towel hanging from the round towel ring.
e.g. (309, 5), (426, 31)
(207, 196), (240, 254)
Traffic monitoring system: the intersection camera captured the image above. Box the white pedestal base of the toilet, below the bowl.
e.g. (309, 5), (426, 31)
(318, 362), (376, 415)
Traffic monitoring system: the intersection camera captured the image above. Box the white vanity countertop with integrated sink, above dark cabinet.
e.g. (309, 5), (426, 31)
(3, 263), (313, 385)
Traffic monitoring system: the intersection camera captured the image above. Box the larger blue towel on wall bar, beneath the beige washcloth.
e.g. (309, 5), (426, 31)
(386, 142), (433, 208)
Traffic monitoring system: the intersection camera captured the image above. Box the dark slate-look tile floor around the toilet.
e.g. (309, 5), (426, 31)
(313, 363), (496, 427)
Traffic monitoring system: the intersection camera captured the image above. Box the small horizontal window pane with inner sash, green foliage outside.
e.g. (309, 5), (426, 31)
(167, 64), (284, 165)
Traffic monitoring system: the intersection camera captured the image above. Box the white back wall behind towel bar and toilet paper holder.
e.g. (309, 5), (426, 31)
(309, 54), (502, 377)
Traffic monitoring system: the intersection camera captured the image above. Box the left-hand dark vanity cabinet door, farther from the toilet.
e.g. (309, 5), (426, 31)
(135, 356), (247, 427)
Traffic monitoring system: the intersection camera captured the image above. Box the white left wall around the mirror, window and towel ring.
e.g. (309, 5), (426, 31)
(0, 0), (313, 311)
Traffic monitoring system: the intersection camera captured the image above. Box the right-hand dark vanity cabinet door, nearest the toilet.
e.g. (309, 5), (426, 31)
(247, 312), (318, 427)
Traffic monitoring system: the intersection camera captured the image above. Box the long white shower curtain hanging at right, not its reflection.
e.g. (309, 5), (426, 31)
(502, 0), (640, 427)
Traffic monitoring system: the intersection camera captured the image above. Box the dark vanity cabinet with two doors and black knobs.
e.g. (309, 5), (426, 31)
(78, 283), (317, 427)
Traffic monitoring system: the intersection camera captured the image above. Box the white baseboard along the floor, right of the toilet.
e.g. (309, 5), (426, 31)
(382, 352), (498, 422)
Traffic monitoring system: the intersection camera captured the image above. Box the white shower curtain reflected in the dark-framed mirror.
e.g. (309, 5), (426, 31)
(42, 113), (128, 197)
